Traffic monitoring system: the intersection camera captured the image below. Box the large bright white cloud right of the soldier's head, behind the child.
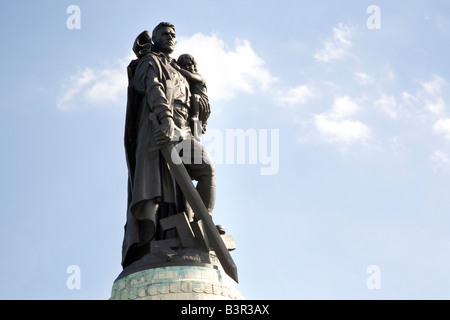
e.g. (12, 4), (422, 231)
(173, 33), (277, 100)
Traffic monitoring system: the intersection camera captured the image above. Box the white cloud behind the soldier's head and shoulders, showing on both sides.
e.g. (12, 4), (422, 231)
(57, 33), (277, 110)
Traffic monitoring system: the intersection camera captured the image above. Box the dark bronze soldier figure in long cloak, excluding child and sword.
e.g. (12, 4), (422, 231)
(122, 22), (216, 268)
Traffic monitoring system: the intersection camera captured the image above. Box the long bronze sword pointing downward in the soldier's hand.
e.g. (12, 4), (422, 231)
(150, 113), (238, 282)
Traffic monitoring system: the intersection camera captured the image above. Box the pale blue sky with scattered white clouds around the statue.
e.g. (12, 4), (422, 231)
(0, 0), (450, 299)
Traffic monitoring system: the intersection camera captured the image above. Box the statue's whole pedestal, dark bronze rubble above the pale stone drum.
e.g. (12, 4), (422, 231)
(110, 212), (242, 300)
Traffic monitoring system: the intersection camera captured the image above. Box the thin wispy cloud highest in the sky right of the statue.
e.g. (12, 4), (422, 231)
(314, 23), (355, 62)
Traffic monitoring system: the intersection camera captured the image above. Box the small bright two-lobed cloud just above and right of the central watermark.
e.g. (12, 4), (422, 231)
(314, 96), (370, 144)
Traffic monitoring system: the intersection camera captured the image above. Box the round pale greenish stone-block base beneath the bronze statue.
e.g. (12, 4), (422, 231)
(110, 266), (242, 300)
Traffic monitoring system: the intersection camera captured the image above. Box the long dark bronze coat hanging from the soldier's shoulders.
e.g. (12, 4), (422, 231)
(122, 52), (181, 267)
